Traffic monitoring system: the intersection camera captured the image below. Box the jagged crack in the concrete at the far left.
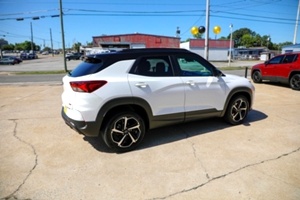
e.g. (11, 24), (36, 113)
(1, 119), (38, 200)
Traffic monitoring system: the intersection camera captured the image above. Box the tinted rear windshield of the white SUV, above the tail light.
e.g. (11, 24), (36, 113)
(70, 57), (103, 77)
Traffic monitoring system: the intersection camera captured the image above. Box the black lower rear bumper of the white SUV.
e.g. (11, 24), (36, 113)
(61, 108), (100, 137)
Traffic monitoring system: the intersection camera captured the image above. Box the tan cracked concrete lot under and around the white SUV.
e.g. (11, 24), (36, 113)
(0, 83), (300, 199)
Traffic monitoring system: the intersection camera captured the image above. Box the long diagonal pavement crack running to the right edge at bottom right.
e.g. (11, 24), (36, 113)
(150, 147), (300, 200)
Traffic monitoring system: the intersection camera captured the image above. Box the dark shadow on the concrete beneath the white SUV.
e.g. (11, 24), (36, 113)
(84, 110), (268, 153)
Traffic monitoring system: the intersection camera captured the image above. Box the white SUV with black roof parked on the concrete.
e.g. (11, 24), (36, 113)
(62, 48), (254, 152)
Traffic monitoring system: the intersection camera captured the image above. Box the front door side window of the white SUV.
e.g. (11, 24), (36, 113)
(177, 55), (213, 76)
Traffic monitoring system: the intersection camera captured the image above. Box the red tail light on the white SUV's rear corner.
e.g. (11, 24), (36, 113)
(70, 81), (107, 93)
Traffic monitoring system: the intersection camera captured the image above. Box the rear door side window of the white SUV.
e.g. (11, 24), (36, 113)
(133, 56), (173, 76)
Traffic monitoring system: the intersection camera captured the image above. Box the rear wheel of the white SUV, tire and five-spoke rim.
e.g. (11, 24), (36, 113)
(102, 111), (145, 152)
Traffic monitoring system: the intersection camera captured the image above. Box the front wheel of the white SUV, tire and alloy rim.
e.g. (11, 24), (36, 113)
(224, 95), (249, 125)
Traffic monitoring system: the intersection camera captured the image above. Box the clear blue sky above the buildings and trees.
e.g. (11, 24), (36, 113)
(0, 0), (300, 48)
